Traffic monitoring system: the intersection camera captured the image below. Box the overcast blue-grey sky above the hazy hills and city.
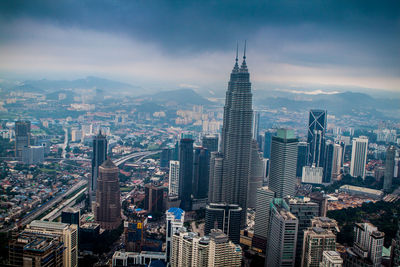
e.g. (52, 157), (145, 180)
(0, 0), (400, 95)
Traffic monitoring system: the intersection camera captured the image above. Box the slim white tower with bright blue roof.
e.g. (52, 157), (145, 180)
(165, 208), (185, 261)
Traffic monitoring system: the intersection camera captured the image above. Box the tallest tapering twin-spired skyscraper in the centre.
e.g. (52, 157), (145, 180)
(221, 46), (253, 226)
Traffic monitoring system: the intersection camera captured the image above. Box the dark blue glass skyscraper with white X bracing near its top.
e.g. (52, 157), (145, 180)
(307, 109), (327, 167)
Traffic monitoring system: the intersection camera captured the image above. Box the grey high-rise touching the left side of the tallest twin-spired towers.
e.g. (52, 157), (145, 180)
(208, 152), (224, 203)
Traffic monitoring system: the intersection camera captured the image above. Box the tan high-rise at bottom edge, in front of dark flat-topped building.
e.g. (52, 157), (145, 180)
(301, 227), (336, 267)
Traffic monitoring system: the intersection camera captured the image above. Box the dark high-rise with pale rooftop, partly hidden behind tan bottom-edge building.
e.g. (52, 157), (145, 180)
(285, 197), (319, 266)
